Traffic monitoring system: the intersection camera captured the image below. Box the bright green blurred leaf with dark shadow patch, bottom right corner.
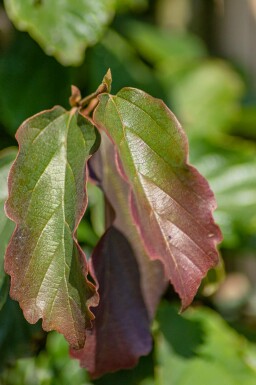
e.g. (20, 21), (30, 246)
(155, 303), (256, 385)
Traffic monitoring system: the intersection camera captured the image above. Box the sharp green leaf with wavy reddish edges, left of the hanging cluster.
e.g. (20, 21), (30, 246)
(5, 107), (99, 348)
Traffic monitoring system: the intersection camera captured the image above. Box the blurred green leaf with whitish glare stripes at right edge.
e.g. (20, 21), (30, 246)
(192, 137), (256, 249)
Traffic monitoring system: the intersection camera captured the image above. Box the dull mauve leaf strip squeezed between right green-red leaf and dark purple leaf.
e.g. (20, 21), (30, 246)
(89, 132), (167, 319)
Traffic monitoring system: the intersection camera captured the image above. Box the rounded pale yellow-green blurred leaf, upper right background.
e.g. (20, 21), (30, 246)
(171, 60), (244, 137)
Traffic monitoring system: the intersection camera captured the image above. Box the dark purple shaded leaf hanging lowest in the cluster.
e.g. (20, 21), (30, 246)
(72, 227), (152, 378)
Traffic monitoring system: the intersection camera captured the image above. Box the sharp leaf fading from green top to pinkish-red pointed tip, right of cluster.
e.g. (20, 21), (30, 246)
(94, 88), (221, 309)
